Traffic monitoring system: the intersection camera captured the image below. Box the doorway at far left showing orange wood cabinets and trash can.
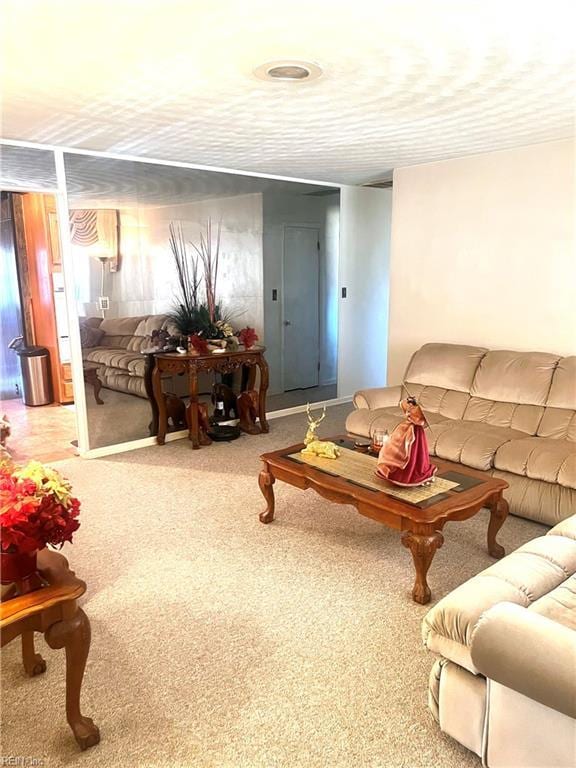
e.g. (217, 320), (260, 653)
(0, 190), (76, 462)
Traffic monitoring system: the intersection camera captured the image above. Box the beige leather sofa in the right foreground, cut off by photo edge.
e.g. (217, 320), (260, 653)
(422, 515), (576, 768)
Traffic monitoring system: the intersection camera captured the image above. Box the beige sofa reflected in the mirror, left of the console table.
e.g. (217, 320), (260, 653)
(82, 315), (180, 397)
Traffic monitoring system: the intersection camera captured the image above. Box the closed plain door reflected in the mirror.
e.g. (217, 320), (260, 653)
(282, 226), (320, 392)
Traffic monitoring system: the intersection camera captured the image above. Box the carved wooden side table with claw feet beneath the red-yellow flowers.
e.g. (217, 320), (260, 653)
(0, 549), (100, 749)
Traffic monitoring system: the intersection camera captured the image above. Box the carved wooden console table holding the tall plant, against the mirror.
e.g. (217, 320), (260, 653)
(145, 347), (269, 448)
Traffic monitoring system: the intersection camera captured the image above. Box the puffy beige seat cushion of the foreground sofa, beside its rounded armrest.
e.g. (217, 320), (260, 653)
(422, 536), (576, 674)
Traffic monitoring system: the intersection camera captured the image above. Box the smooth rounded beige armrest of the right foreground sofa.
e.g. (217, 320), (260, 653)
(471, 603), (576, 718)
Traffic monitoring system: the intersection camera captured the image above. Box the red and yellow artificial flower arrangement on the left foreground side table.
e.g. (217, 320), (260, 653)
(0, 461), (80, 555)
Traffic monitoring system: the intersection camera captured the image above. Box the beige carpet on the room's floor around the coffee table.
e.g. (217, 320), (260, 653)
(2, 406), (543, 768)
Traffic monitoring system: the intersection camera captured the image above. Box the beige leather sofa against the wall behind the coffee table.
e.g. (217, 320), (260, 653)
(346, 344), (576, 525)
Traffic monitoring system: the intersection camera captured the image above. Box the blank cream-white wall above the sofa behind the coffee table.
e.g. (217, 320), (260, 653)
(388, 141), (576, 384)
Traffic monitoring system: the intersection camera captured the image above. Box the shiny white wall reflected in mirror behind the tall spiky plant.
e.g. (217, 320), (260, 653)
(76, 194), (264, 334)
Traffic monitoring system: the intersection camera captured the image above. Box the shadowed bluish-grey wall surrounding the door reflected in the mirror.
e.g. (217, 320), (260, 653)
(263, 192), (339, 394)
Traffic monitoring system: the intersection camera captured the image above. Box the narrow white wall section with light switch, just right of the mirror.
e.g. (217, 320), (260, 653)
(338, 187), (392, 397)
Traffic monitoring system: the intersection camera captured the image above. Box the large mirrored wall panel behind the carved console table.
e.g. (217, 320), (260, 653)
(65, 154), (339, 449)
